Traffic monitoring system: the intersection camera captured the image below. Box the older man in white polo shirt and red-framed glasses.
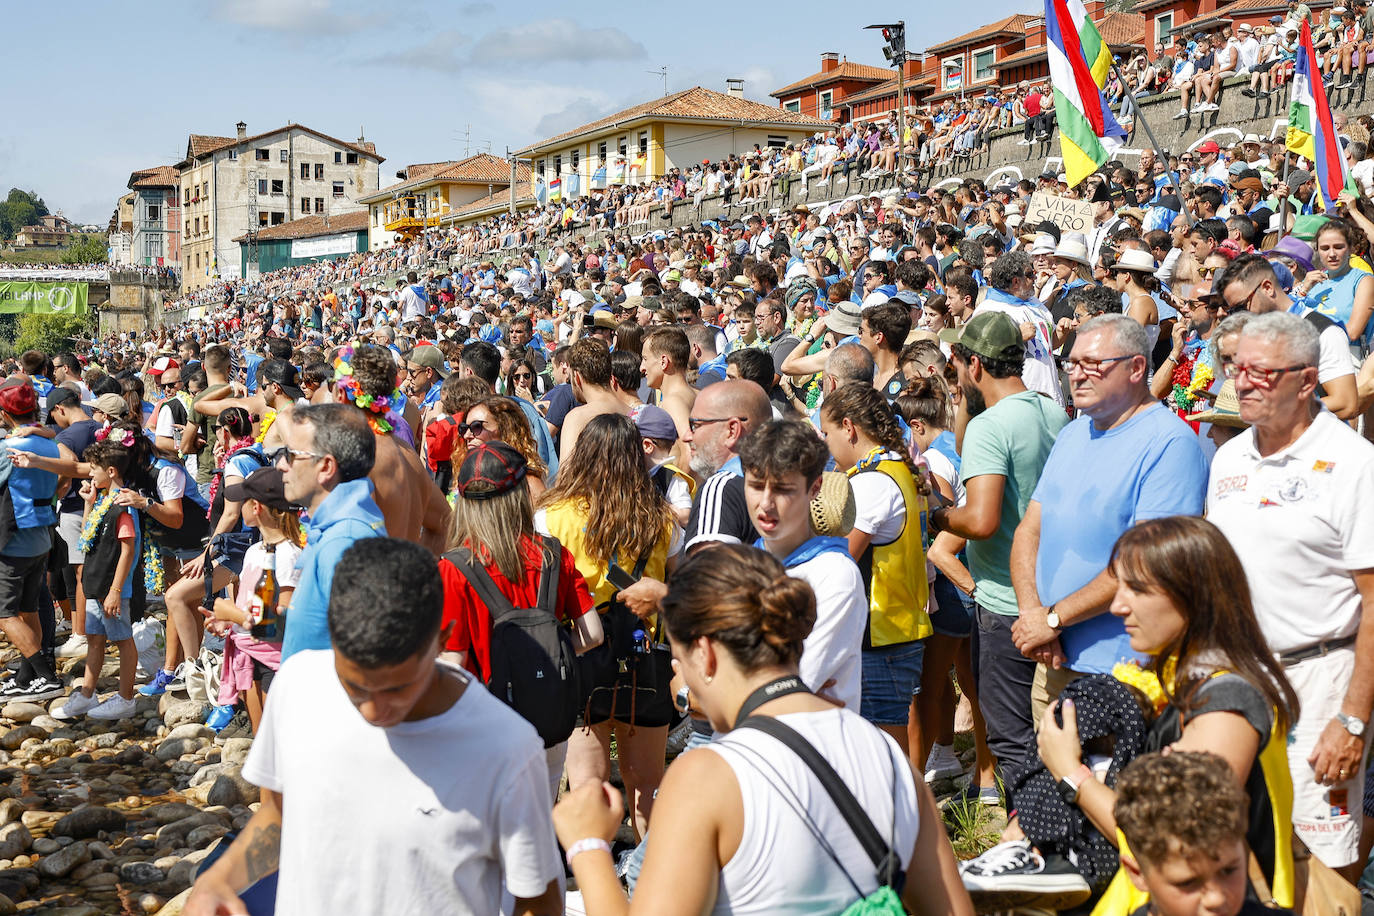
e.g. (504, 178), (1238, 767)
(1208, 312), (1374, 882)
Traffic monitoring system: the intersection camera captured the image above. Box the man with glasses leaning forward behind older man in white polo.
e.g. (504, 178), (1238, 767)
(1217, 254), (1359, 420)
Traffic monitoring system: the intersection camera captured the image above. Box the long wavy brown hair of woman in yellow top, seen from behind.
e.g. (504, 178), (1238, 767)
(539, 413), (673, 564)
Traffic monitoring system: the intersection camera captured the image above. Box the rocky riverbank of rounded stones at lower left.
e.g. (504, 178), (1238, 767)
(0, 658), (258, 916)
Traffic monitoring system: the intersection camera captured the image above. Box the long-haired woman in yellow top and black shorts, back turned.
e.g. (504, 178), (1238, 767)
(535, 411), (682, 839)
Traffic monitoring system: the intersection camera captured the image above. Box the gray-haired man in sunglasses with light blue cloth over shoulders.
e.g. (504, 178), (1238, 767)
(269, 404), (386, 662)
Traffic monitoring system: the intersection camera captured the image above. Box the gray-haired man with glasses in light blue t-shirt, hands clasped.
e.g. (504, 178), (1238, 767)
(1011, 314), (1208, 721)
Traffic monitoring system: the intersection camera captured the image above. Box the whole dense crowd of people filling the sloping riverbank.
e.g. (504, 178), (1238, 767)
(0, 4), (1374, 916)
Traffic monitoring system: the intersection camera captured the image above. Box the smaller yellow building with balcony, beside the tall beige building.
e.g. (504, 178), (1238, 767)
(359, 152), (529, 250)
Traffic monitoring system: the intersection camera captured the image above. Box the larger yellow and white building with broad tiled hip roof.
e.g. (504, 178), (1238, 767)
(517, 81), (835, 196)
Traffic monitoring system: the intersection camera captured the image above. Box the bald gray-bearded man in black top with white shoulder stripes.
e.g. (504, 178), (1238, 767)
(683, 379), (772, 552)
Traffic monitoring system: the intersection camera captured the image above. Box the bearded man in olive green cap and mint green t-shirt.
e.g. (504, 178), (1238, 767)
(930, 310), (1069, 773)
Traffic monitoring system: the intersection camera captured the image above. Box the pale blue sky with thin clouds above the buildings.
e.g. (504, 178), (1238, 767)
(0, 0), (1039, 225)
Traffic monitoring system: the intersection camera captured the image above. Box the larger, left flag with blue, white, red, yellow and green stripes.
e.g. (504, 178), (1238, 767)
(1044, 0), (1125, 188)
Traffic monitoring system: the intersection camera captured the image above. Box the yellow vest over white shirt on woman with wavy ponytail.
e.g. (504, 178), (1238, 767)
(849, 459), (934, 648)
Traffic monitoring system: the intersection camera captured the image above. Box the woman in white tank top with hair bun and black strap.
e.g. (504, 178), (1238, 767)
(554, 543), (973, 916)
